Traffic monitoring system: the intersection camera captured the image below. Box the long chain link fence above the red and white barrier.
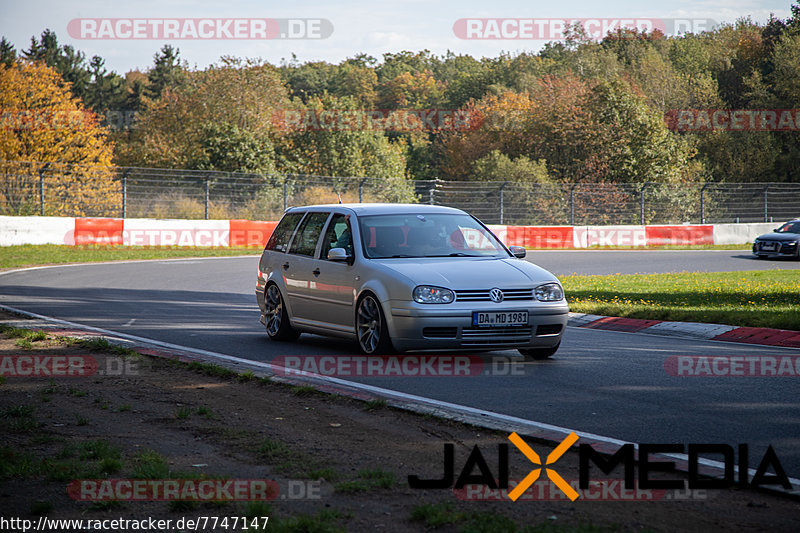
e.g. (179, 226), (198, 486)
(0, 162), (800, 225)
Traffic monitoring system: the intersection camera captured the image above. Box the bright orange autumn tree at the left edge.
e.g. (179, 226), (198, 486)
(0, 61), (120, 216)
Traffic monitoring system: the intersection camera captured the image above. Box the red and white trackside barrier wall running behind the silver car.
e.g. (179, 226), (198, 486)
(0, 216), (778, 249)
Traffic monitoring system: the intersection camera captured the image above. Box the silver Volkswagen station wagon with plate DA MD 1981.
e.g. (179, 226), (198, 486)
(256, 204), (569, 359)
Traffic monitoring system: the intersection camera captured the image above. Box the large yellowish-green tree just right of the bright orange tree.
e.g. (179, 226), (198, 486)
(116, 57), (290, 170)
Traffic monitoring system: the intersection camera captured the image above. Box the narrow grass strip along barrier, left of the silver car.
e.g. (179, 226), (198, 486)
(0, 244), (261, 268)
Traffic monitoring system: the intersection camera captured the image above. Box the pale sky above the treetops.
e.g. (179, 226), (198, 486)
(0, 0), (790, 74)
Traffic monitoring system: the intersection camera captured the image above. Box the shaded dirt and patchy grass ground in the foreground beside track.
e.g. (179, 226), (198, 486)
(0, 318), (800, 532)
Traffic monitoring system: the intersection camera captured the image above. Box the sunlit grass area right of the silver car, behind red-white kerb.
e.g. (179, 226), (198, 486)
(561, 270), (800, 329)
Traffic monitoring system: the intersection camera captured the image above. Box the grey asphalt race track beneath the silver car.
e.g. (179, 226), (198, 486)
(0, 251), (800, 477)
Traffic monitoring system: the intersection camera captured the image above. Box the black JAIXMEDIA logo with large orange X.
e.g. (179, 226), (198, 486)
(408, 432), (793, 501)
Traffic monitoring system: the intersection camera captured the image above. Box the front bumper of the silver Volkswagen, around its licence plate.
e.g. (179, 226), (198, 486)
(387, 301), (569, 351)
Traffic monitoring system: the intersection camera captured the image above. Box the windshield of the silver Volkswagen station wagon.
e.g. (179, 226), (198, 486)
(359, 214), (508, 259)
